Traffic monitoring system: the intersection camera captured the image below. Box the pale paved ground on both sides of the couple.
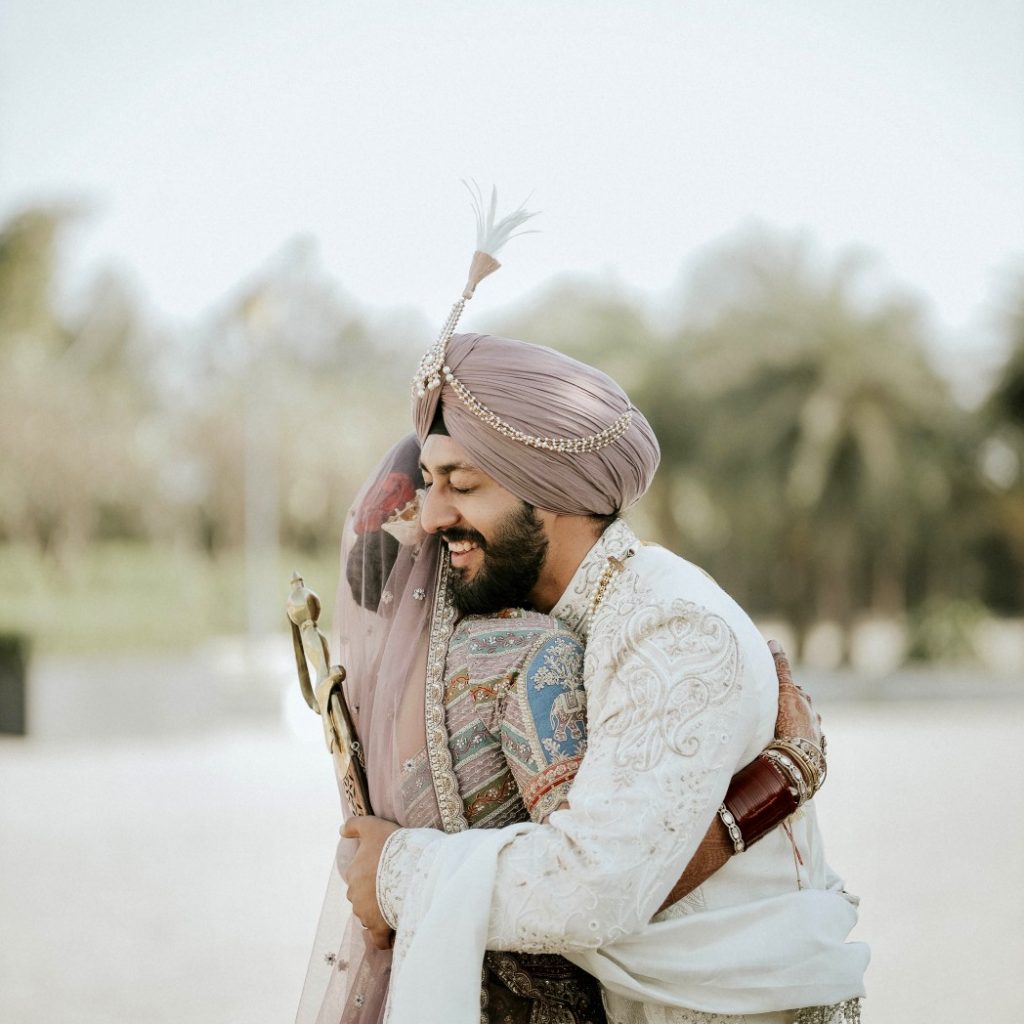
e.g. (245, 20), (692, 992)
(0, 655), (1024, 1024)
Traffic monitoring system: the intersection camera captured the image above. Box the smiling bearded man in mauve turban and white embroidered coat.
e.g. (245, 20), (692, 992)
(346, 335), (866, 1024)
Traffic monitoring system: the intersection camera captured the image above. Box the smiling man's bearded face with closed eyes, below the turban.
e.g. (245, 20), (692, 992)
(420, 434), (548, 614)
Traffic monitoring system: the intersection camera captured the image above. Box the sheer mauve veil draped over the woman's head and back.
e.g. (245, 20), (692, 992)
(296, 434), (450, 1024)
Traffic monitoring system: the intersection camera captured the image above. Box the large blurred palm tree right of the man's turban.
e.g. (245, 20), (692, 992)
(648, 229), (970, 659)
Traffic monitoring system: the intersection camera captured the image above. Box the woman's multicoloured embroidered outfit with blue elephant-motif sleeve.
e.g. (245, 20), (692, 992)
(411, 610), (605, 1024)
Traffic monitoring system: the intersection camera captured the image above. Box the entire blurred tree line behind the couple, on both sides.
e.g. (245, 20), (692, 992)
(0, 208), (1024, 659)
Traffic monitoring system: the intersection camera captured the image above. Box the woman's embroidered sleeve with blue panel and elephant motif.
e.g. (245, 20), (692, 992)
(501, 631), (587, 821)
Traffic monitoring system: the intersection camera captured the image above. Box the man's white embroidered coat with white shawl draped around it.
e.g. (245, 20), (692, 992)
(378, 521), (866, 1024)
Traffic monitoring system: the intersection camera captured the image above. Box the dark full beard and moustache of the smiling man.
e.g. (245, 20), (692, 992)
(443, 502), (548, 615)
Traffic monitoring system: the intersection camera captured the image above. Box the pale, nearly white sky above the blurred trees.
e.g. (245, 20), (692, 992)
(0, 0), (1024, 376)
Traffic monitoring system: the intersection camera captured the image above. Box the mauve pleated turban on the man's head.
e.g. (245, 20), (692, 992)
(413, 334), (660, 515)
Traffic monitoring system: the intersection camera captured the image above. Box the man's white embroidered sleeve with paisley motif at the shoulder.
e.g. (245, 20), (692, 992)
(372, 573), (758, 953)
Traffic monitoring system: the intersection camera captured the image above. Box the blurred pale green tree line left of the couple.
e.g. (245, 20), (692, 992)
(0, 209), (409, 561)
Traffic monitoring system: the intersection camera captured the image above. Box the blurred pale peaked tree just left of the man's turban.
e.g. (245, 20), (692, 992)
(177, 245), (411, 552)
